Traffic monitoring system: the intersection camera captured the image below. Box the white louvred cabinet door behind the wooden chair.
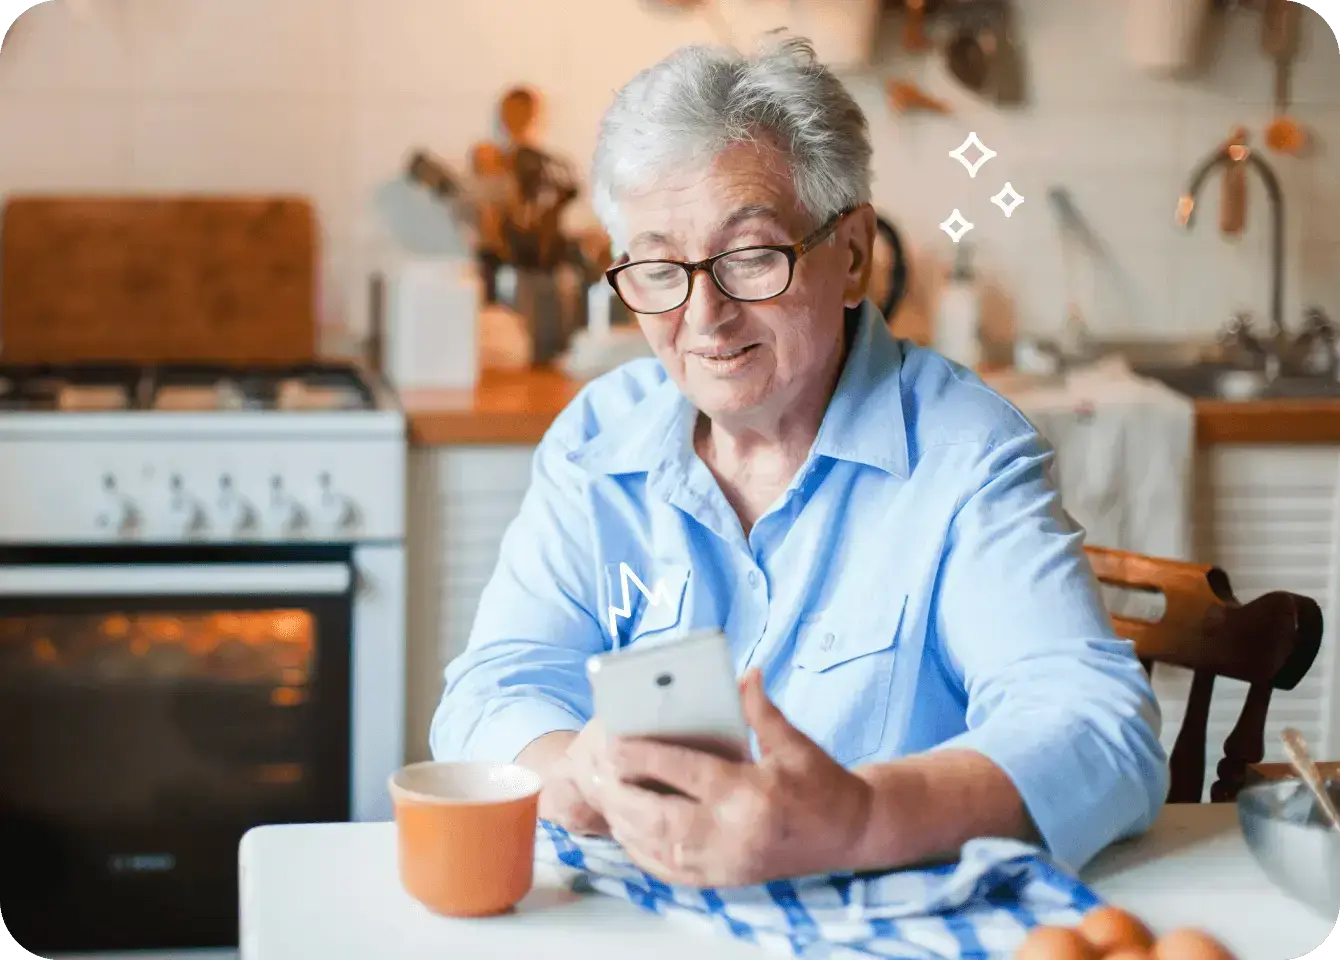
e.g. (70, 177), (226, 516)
(1155, 446), (1340, 796)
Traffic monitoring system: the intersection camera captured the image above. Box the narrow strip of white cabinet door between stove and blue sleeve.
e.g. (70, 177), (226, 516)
(405, 446), (535, 763)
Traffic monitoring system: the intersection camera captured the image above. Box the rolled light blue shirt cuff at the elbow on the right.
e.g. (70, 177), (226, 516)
(931, 719), (1166, 873)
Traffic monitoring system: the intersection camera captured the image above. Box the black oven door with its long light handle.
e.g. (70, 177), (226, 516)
(0, 547), (354, 955)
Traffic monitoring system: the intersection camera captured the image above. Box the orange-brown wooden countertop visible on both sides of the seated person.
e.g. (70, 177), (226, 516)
(401, 369), (1340, 446)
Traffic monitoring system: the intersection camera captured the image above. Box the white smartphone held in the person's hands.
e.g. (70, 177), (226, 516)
(587, 630), (752, 762)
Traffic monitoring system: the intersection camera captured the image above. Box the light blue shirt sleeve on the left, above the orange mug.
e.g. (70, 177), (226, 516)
(429, 417), (604, 763)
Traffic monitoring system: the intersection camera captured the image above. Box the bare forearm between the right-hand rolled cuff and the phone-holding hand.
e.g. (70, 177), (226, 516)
(843, 749), (1037, 870)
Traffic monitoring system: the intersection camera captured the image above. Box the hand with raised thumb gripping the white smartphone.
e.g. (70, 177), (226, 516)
(595, 670), (872, 886)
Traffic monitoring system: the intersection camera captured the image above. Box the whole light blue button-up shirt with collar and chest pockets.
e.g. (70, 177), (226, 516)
(431, 303), (1168, 869)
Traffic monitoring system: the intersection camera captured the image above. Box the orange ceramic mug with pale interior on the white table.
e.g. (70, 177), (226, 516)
(390, 760), (541, 917)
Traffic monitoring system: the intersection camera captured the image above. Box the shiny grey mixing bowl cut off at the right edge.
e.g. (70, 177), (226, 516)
(1238, 780), (1340, 920)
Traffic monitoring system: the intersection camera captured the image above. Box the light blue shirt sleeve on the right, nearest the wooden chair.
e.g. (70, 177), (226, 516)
(935, 433), (1168, 870)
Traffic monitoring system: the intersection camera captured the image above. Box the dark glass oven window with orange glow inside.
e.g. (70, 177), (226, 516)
(0, 607), (328, 821)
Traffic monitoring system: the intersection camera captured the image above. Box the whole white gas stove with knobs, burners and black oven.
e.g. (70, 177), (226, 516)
(0, 365), (406, 956)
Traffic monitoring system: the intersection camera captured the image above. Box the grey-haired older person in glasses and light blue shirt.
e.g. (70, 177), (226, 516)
(431, 40), (1167, 885)
